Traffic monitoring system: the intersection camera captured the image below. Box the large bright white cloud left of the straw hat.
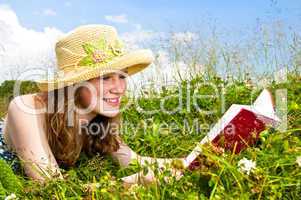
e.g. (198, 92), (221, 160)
(0, 5), (63, 82)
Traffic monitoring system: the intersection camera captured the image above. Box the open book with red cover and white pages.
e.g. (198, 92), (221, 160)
(184, 89), (280, 170)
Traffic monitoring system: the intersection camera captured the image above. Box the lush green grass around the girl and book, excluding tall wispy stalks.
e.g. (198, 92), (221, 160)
(0, 72), (301, 199)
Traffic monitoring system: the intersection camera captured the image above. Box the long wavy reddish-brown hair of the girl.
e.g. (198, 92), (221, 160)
(35, 85), (120, 167)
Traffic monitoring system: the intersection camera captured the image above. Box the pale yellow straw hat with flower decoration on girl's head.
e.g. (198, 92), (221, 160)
(35, 25), (154, 91)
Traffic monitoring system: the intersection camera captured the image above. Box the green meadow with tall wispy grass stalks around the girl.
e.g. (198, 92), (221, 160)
(0, 24), (301, 199)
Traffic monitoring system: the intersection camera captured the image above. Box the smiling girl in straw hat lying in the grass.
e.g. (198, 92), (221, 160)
(0, 25), (184, 183)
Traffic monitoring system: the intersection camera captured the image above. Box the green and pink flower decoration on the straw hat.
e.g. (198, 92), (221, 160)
(78, 37), (124, 67)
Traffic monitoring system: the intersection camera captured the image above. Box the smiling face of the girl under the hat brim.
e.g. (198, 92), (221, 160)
(80, 71), (127, 117)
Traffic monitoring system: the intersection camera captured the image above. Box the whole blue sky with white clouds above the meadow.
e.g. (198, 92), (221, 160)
(0, 0), (301, 82)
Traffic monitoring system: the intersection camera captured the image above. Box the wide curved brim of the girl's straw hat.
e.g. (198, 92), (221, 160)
(35, 49), (154, 91)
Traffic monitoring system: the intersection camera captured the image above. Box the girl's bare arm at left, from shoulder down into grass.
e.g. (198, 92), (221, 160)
(7, 95), (62, 182)
